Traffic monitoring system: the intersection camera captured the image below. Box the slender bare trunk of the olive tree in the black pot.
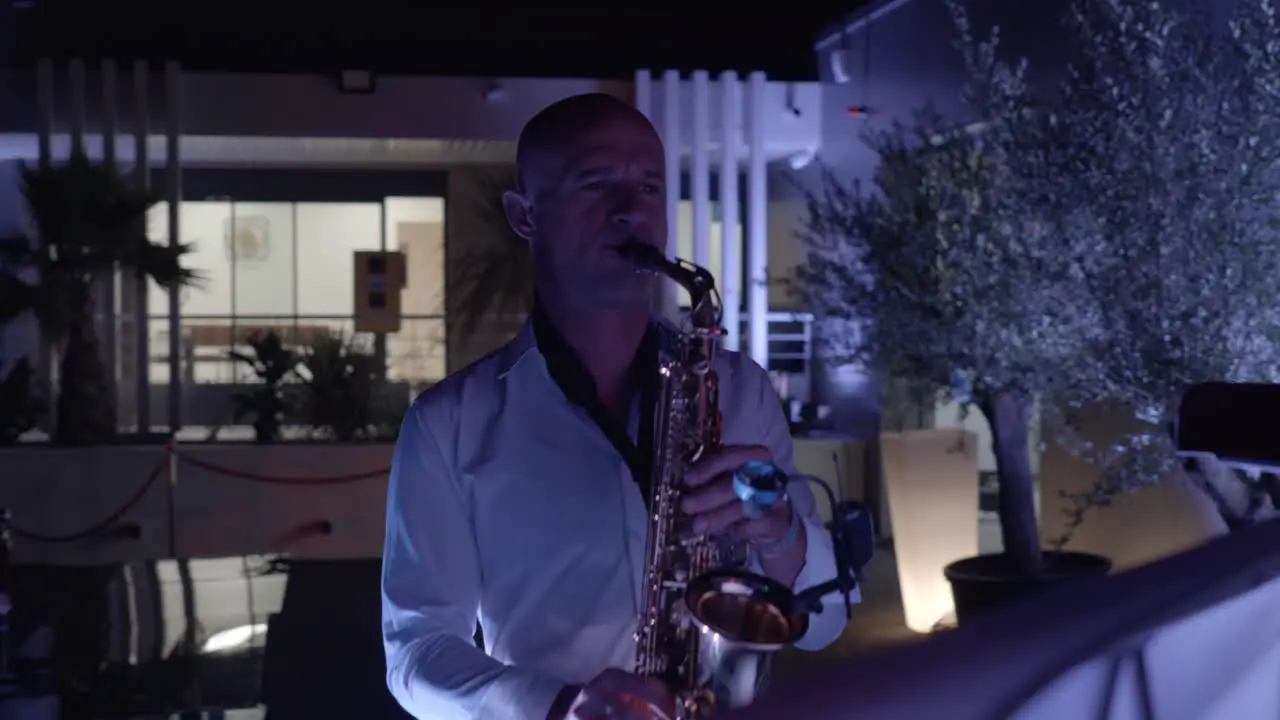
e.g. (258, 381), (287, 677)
(978, 391), (1044, 578)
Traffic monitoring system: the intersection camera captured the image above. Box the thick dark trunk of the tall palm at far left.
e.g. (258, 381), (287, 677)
(55, 281), (116, 445)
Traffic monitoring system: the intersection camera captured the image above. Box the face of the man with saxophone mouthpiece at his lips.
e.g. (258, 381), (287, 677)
(514, 113), (667, 309)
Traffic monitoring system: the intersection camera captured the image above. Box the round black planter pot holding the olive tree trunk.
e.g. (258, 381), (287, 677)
(942, 551), (1111, 624)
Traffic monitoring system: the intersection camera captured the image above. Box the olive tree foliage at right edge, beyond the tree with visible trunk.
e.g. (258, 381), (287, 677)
(1042, 0), (1280, 527)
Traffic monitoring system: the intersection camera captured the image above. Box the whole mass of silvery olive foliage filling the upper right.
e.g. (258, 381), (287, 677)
(799, 0), (1280, 551)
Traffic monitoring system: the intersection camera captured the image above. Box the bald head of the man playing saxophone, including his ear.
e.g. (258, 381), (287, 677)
(503, 94), (667, 310)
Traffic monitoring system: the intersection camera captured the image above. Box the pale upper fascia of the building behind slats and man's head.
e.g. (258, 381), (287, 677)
(0, 68), (822, 163)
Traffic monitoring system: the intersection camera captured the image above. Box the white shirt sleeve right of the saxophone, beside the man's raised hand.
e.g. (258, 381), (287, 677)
(751, 363), (860, 651)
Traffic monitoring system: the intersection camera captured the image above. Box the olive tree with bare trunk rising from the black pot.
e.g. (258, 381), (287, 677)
(797, 6), (1103, 577)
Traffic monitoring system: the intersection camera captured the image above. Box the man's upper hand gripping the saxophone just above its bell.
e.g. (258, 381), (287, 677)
(681, 445), (806, 587)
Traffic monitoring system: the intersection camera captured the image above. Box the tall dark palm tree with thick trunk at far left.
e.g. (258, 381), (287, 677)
(0, 154), (197, 445)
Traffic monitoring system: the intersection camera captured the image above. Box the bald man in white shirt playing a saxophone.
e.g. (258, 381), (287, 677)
(383, 95), (845, 720)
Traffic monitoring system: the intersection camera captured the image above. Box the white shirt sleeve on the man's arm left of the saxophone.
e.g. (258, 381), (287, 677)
(383, 402), (563, 720)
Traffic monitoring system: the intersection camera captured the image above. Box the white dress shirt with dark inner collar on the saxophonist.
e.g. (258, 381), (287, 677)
(383, 317), (845, 720)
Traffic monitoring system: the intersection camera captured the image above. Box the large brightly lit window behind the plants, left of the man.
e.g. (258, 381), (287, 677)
(140, 197), (447, 428)
